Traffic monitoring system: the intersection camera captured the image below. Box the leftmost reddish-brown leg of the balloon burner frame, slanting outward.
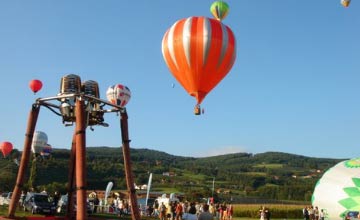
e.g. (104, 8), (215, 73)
(8, 104), (40, 218)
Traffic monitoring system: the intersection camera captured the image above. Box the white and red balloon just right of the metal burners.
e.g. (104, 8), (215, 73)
(106, 84), (131, 107)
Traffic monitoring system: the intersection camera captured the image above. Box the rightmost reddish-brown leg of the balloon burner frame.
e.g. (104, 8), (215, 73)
(120, 111), (141, 220)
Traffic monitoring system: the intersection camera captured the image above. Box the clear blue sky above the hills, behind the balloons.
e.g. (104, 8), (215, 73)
(0, 0), (360, 158)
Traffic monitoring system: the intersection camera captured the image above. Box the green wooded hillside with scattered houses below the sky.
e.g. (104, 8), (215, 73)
(0, 147), (341, 201)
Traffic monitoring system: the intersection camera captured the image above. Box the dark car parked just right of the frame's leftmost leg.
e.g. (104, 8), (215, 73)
(23, 193), (56, 215)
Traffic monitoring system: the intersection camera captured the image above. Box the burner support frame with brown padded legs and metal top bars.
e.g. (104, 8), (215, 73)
(8, 92), (140, 220)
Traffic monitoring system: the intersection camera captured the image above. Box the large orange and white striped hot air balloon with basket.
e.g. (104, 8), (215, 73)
(162, 17), (236, 114)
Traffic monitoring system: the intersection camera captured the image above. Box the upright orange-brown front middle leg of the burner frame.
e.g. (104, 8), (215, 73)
(75, 97), (87, 220)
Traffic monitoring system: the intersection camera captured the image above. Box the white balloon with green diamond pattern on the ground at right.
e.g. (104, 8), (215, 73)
(312, 158), (360, 219)
